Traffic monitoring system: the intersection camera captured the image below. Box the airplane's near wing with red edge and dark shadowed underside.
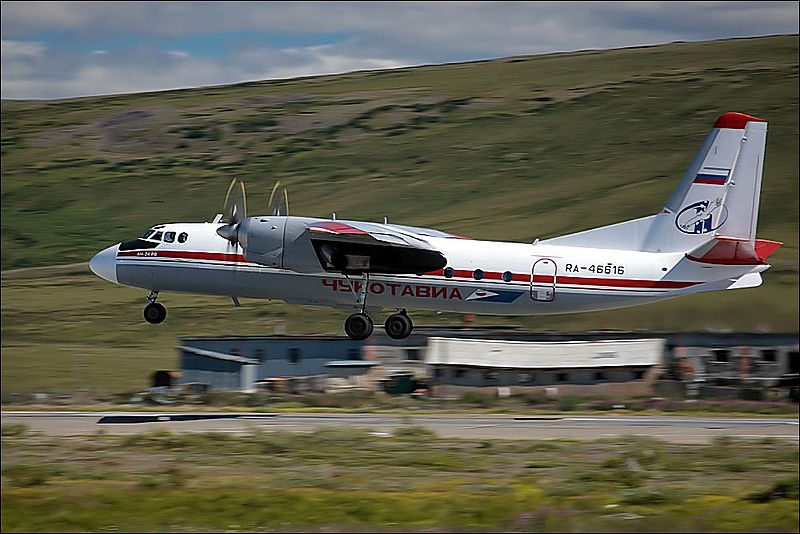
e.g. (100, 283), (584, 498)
(308, 221), (447, 274)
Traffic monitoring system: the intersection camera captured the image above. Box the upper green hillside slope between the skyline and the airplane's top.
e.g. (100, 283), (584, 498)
(2, 36), (798, 269)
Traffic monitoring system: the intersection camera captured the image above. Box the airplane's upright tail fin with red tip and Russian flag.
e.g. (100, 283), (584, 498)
(642, 113), (767, 252)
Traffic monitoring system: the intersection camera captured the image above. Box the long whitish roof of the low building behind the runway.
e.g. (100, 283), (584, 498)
(425, 337), (664, 369)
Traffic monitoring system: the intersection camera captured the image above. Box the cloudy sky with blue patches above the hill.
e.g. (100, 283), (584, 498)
(0, 1), (798, 99)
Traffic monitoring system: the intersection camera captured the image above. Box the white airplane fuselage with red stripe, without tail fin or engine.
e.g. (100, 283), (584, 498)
(92, 223), (768, 315)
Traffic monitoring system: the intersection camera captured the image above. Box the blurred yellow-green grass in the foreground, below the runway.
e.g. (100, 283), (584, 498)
(2, 434), (798, 532)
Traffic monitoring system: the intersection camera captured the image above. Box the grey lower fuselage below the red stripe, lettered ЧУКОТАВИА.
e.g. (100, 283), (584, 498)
(117, 259), (677, 315)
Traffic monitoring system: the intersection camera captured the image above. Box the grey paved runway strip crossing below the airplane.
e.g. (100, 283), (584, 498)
(2, 411), (800, 443)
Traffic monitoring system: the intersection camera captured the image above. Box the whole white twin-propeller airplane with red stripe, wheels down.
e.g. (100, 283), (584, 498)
(89, 112), (782, 340)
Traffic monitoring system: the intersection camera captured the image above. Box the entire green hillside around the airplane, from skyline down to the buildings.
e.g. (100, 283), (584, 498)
(2, 36), (798, 393)
